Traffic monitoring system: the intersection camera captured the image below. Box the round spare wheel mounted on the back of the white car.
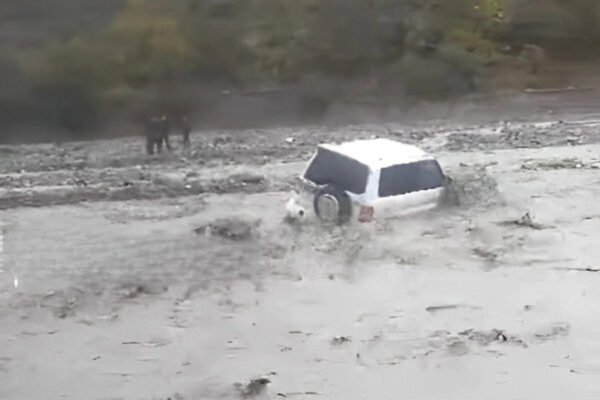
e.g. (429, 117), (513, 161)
(313, 185), (352, 225)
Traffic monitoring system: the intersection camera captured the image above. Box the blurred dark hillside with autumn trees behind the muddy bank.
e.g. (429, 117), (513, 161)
(0, 0), (600, 141)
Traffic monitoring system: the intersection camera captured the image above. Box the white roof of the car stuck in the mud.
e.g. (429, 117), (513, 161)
(319, 138), (433, 170)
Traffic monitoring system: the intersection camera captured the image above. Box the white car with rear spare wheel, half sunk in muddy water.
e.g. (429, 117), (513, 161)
(287, 139), (446, 224)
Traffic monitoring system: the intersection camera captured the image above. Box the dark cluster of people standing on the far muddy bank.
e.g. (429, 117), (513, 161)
(144, 115), (191, 154)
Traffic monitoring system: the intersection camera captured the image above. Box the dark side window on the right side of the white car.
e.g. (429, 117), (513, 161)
(379, 160), (444, 197)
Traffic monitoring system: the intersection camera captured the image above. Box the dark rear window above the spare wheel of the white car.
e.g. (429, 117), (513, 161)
(304, 148), (369, 194)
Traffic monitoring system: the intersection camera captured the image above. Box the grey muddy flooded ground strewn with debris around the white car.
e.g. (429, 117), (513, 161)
(0, 91), (600, 400)
